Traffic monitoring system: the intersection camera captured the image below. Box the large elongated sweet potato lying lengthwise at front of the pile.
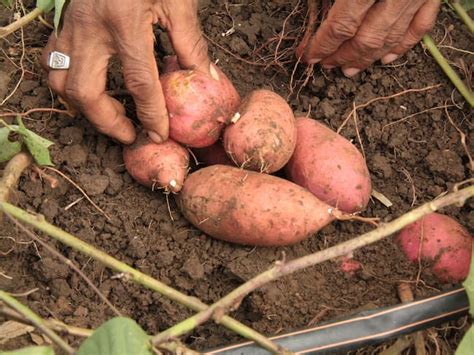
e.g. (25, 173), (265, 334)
(176, 165), (334, 246)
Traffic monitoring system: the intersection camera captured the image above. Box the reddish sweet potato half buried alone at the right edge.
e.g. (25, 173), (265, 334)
(396, 213), (472, 283)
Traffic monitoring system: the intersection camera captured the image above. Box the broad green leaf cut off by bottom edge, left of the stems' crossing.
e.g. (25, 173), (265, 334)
(76, 317), (152, 355)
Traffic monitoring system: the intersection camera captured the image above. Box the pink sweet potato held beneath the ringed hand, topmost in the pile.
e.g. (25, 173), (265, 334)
(160, 66), (240, 148)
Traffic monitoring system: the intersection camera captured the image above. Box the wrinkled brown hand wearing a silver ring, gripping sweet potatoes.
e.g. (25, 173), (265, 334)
(43, 0), (210, 144)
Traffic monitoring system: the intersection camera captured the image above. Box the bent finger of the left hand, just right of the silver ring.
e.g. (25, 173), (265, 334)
(65, 27), (135, 144)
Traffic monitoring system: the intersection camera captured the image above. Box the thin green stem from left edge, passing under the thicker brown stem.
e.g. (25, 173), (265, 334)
(0, 201), (284, 354)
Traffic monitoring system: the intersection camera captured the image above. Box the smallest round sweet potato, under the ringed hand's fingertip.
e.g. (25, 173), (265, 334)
(123, 133), (189, 192)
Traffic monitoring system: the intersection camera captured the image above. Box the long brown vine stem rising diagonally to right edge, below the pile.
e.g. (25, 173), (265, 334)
(152, 185), (474, 344)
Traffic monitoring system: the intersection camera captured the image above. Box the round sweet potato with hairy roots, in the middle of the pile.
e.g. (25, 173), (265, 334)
(223, 90), (296, 173)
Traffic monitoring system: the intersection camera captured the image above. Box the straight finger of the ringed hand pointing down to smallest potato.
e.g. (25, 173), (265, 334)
(116, 21), (169, 143)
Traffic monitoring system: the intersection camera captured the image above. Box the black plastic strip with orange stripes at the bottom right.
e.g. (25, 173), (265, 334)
(206, 288), (469, 355)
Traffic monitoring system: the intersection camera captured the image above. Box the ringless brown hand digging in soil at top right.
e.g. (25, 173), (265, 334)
(298, 0), (441, 77)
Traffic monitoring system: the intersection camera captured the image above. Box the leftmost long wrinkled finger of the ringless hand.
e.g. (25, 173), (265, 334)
(302, 0), (375, 64)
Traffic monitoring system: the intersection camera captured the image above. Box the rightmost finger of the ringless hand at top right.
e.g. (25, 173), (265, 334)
(382, 0), (441, 63)
